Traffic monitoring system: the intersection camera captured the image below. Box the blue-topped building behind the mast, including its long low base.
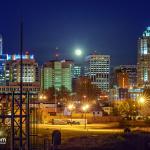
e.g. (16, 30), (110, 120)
(0, 52), (40, 93)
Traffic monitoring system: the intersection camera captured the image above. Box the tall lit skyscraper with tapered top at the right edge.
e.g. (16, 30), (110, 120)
(137, 27), (150, 87)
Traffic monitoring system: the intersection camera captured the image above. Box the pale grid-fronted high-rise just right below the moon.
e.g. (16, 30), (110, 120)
(85, 54), (110, 92)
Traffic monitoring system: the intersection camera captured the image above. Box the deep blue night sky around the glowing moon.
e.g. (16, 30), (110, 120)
(0, 0), (150, 66)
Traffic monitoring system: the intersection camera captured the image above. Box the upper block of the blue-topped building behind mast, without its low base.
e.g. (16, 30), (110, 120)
(5, 52), (40, 85)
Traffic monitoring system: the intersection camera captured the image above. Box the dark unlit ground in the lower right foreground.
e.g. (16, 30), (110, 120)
(58, 133), (150, 150)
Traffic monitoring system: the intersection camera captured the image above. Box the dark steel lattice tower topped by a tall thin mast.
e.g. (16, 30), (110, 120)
(11, 20), (30, 150)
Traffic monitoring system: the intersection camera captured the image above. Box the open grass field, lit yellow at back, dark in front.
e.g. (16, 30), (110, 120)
(29, 125), (150, 150)
